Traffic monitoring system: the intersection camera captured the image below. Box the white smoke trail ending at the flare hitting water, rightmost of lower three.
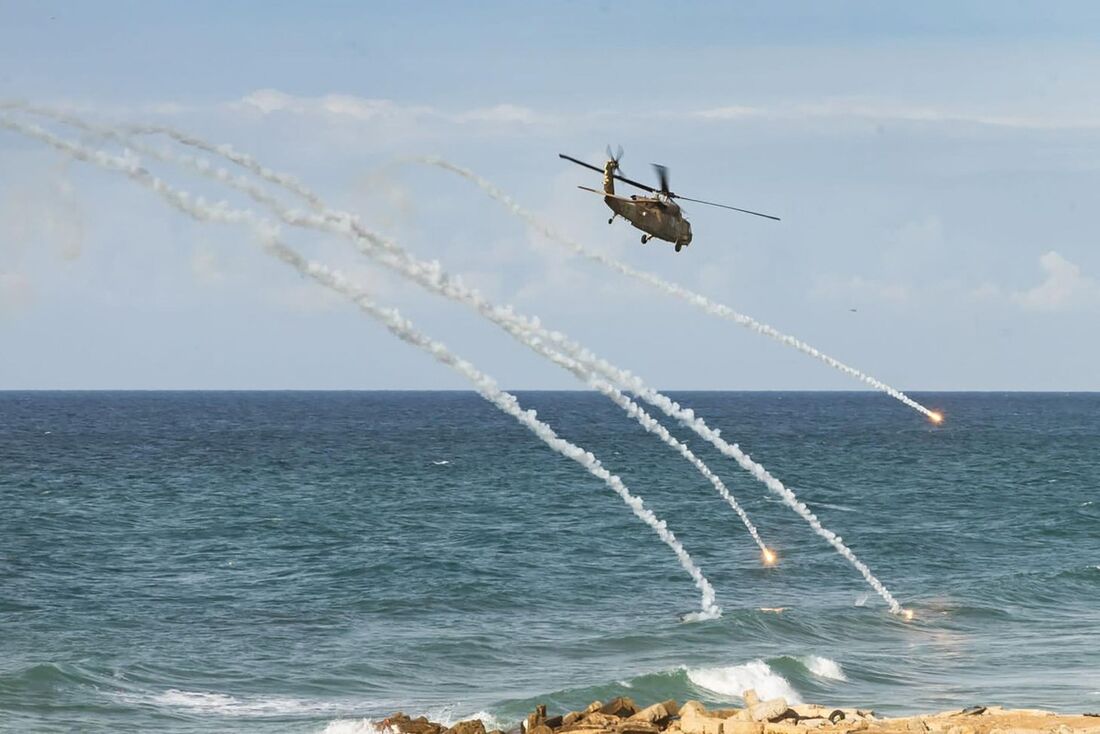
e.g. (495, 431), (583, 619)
(23, 106), (908, 615)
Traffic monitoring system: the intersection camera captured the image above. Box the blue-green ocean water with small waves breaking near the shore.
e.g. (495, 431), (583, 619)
(0, 393), (1100, 733)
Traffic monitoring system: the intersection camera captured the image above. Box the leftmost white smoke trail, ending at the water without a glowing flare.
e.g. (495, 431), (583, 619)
(0, 117), (722, 620)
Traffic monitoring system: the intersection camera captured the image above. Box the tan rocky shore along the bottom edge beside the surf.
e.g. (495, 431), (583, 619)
(376, 690), (1100, 734)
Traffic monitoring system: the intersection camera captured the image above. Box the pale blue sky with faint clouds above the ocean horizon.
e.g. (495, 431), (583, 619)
(0, 0), (1100, 391)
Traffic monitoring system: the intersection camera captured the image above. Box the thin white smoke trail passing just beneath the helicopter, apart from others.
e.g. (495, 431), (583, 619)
(413, 156), (943, 423)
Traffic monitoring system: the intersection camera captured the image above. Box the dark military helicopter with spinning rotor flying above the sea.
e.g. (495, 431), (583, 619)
(558, 145), (779, 252)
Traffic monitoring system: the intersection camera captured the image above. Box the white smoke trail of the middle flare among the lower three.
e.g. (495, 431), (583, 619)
(6, 107), (774, 563)
